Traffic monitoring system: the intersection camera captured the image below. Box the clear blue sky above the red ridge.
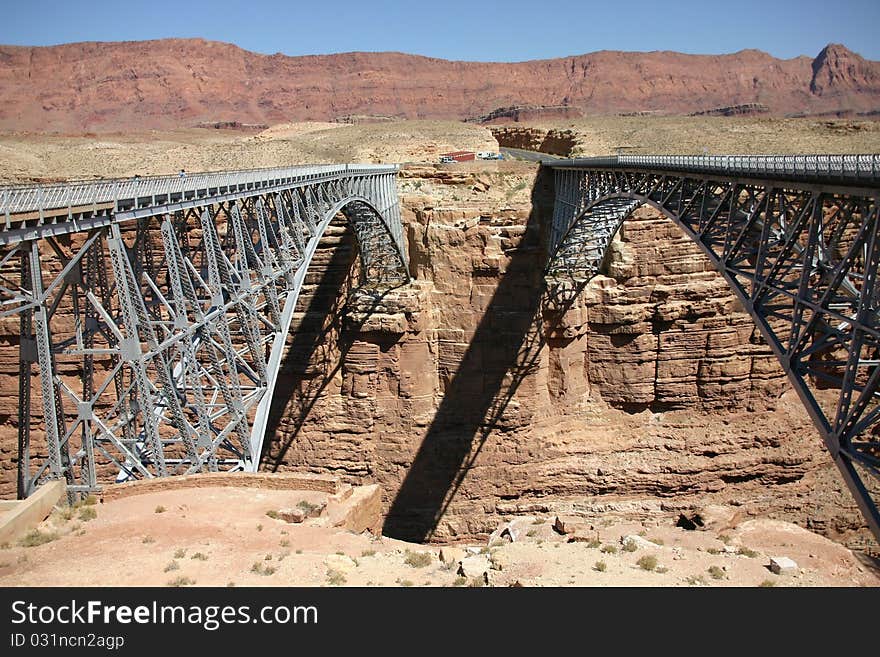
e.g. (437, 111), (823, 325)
(0, 0), (880, 61)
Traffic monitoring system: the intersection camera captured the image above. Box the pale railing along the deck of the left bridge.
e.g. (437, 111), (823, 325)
(0, 164), (397, 224)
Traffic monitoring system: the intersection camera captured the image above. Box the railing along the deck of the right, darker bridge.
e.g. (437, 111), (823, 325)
(542, 154), (880, 184)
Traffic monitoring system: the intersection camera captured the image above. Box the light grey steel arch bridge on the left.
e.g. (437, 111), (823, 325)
(0, 165), (409, 497)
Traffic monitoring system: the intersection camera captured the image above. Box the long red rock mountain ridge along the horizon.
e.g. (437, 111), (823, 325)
(0, 39), (880, 132)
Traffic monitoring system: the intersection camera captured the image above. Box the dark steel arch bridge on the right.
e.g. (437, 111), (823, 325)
(542, 155), (880, 541)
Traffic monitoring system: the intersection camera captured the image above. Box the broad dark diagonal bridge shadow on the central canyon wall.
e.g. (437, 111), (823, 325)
(382, 168), (553, 542)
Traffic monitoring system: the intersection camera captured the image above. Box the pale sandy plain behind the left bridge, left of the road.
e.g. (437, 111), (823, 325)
(0, 121), (498, 182)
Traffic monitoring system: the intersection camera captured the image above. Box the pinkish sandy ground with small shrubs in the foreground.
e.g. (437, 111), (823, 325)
(0, 488), (880, 587)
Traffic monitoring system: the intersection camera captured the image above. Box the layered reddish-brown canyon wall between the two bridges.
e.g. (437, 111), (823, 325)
(264, 168), (862, 541)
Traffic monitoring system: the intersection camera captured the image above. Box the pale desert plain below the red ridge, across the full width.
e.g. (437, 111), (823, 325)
(0, 116), (880, 183)
